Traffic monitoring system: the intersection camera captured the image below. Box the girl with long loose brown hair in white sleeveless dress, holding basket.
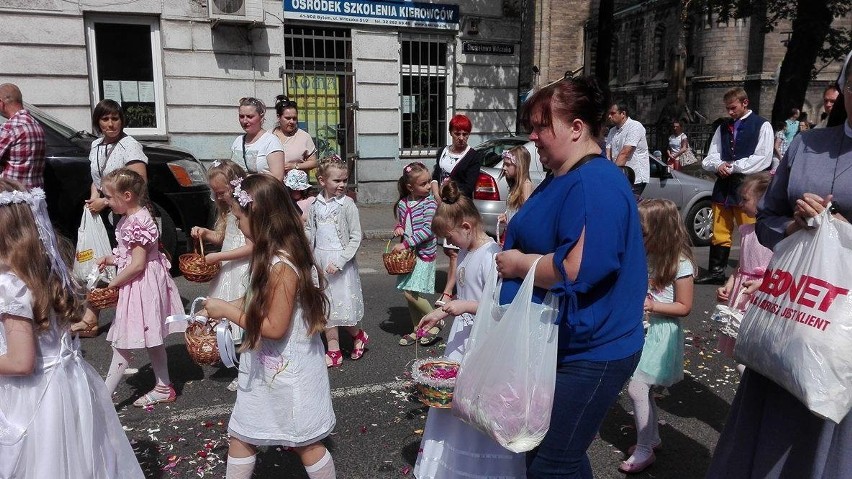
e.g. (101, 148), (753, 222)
(202, 175), (336, 479)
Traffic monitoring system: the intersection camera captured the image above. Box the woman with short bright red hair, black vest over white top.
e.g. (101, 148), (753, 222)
(426, 115), (482, 314)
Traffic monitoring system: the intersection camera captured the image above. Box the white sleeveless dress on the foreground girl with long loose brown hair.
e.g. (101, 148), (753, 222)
(228, 258), (335, 447)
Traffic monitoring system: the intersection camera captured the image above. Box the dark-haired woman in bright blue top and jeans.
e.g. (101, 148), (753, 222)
(497, 77), (648, 478)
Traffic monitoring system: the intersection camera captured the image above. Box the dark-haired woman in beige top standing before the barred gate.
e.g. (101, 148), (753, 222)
(272, 95), (317, 174)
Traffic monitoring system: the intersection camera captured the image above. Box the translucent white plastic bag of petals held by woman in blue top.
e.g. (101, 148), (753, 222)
(452, 258), (558, 452)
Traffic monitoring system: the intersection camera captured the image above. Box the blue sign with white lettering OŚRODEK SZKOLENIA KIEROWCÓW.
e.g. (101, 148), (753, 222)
(284, 0), (459, 30)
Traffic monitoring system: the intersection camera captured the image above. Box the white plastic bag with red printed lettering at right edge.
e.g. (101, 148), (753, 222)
(734, 211), (852, 423)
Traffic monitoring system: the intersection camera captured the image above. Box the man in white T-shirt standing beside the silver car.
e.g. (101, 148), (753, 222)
(606, 103), (651, 197)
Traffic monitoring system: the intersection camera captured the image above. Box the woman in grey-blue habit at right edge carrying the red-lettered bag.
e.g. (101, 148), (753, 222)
(707, 48), (852, 479)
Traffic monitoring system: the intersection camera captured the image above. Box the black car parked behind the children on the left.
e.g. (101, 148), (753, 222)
(26, 105), (215, 258)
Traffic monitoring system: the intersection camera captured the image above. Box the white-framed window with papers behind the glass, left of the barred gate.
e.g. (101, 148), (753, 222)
(86, 17), (166, 136)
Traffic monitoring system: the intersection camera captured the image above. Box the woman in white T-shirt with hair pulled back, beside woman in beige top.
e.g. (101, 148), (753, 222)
(231, 97), (284, 182)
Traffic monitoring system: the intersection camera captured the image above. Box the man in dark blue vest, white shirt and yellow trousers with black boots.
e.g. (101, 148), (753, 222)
(695, 87), (775, 284)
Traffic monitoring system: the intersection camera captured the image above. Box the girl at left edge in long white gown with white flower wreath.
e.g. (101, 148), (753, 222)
(0, 179), (144, 479)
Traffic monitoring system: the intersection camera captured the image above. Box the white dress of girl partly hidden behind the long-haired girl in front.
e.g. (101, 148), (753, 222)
(210, 213), (251, 342)
